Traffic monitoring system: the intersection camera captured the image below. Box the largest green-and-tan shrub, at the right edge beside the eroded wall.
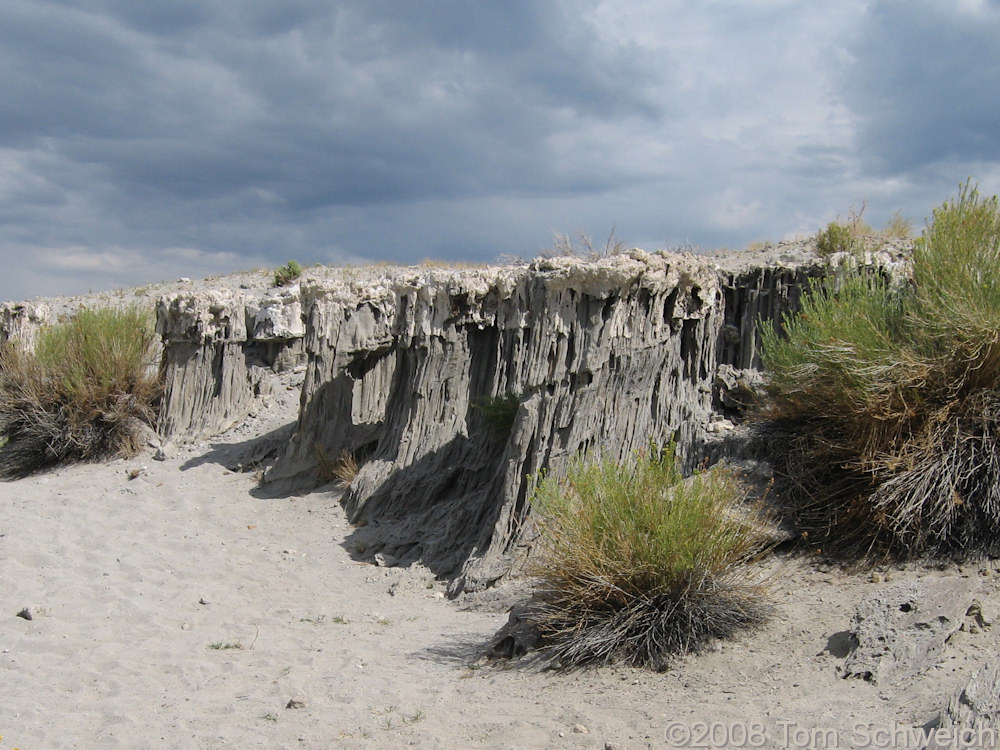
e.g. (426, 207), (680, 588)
(764, 183), (1000, 557)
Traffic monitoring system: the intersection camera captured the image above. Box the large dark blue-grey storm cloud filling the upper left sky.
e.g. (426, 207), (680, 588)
(0, 3), (655, 209)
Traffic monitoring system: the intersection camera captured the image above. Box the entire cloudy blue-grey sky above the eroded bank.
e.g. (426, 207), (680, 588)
(0, 0), (1000, 300)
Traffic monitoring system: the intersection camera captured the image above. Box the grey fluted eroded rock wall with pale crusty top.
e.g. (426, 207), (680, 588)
(152, 243), (912, 593)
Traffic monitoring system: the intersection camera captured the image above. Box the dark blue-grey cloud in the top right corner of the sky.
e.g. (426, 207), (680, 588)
(845, 0), (1000, 175)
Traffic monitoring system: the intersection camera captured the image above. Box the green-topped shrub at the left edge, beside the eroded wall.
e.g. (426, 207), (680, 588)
(0, 307), (159, 477)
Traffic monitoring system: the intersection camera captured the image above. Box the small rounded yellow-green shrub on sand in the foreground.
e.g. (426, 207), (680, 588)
(528, 446), (770, 667)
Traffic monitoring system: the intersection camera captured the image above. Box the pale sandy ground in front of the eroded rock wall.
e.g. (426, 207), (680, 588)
(0, 372), (1000, 750)
